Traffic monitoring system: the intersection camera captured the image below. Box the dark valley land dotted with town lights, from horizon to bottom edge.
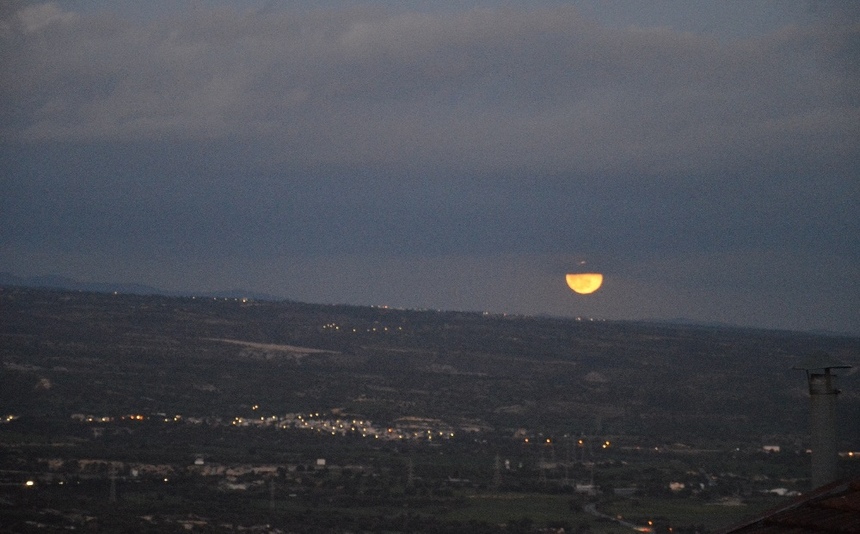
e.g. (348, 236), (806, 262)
(0, 287), (860, 532)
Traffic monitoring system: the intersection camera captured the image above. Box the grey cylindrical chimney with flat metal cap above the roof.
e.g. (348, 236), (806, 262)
(792, 352), (851, 489)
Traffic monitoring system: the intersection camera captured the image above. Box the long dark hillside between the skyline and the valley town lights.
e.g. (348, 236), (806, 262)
(0, 288), (860, 441)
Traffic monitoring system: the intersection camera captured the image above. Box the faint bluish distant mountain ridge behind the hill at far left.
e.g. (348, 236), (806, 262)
(0, 272), (287, 301)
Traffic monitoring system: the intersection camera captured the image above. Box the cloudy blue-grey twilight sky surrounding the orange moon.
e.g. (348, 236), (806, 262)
(0, 0), (860, 334)
